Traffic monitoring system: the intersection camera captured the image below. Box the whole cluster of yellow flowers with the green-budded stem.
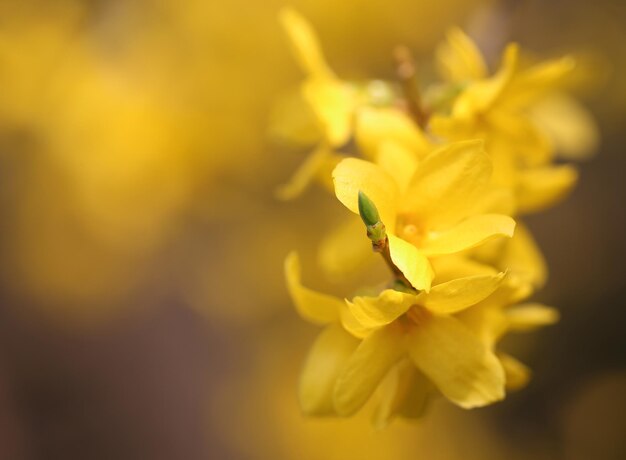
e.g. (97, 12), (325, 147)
(278, 10), (595, 426)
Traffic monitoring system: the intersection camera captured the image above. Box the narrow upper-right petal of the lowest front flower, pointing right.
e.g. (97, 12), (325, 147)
(417, 273), (504, 314)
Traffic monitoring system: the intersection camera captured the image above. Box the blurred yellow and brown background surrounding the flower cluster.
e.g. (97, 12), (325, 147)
(0, 0), (626, 460)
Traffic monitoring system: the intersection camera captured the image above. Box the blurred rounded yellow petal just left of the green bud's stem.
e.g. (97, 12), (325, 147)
(318, 215), (379, 279)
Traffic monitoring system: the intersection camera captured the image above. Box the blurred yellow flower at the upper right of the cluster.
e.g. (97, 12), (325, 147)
(429, 29), (597, 213)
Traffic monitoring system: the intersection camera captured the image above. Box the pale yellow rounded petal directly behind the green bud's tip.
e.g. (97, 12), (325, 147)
(333, 158), (398, 233)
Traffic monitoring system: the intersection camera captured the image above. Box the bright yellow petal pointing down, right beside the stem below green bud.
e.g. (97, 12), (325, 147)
(387, 234), (435, 291)
